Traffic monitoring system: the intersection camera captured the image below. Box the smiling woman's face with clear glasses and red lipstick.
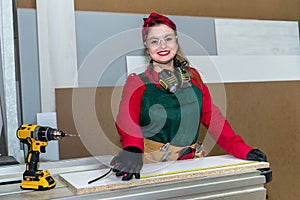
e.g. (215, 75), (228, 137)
(145, 24), (178, 67)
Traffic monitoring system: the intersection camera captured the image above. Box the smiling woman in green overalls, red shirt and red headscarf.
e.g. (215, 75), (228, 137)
(111, 13), (266, 180)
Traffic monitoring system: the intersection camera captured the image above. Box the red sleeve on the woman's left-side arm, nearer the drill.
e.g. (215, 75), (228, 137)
(116, 74), (145, 152)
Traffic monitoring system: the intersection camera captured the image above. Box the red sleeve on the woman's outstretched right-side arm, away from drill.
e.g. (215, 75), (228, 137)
(192, 70), (253, 159)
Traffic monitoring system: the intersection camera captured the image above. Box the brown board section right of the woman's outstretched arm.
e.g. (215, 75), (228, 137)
(225, 81), (300, 200)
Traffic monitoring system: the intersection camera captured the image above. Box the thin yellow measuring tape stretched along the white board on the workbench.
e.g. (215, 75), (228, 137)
(141, 161), (258, 179)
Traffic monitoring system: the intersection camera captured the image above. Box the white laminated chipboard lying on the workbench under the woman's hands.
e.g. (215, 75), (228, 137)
(60, 155), (269, 194)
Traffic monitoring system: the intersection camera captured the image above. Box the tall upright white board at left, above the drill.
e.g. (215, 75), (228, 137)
(36, 0), (77, 112)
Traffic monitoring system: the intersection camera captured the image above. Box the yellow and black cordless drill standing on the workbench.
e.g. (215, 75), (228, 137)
(17, 124), (75, 190)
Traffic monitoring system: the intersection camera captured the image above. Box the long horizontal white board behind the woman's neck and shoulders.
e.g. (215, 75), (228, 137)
(126, 56), (300, 83)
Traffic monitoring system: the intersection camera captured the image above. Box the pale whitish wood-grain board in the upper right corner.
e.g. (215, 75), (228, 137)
(215, 19), (300, 55)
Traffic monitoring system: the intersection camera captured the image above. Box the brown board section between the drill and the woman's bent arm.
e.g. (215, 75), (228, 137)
(55, 87), (121, 159)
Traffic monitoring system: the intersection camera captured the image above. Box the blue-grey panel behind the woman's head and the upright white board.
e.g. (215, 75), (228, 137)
(18, 9), (217, 123)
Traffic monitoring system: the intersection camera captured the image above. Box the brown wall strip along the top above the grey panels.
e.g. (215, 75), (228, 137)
(18, 0), (300, 26)
